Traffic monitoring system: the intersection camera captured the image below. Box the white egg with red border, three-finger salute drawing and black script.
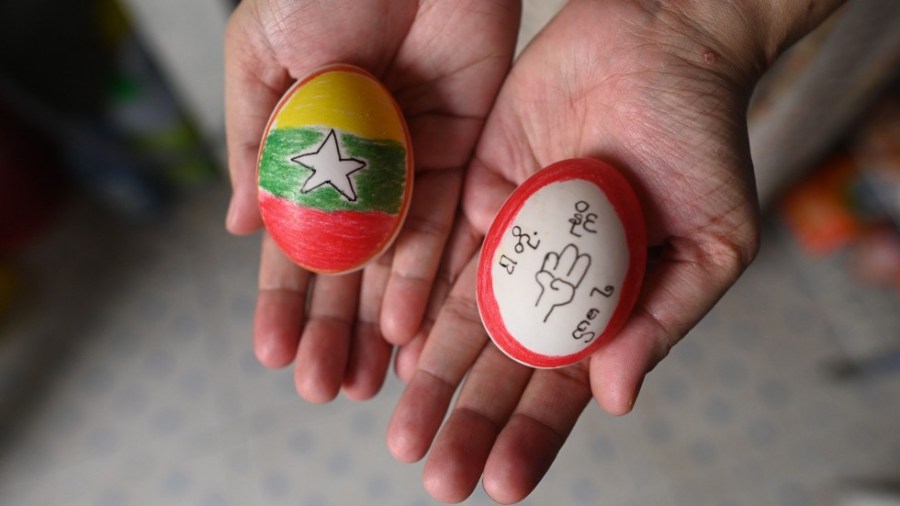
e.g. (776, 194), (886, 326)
(477, 158), (647, 368)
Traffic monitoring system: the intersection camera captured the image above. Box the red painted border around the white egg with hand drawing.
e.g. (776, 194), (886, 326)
(476, 158), (647, 368)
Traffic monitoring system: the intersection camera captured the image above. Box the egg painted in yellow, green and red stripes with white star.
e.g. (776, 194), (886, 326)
(258, 65), (413, 274)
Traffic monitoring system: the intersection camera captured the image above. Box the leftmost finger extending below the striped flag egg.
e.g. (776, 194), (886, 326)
(253, 234), (311, 367)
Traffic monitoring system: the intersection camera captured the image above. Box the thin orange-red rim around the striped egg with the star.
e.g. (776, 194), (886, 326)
(256, 63), (415, 274)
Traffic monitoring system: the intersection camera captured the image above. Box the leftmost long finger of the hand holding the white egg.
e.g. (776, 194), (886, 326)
(387, 257), (487, 462)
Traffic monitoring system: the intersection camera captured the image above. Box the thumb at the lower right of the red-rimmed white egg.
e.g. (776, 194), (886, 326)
(591, 234), (757, 415)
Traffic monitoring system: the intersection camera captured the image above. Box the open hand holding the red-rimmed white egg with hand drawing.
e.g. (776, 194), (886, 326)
(388, 0), (844, 503)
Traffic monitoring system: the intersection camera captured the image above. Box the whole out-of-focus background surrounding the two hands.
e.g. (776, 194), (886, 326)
(0, 0), (900, 506)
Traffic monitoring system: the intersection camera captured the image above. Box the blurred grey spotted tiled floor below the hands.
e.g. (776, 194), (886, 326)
(0, 183), (900, 506)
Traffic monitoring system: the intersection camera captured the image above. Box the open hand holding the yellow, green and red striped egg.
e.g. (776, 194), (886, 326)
(225, 0), (519, 402)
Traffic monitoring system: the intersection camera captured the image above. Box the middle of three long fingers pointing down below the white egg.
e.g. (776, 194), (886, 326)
(424, 345), (533, 502)
